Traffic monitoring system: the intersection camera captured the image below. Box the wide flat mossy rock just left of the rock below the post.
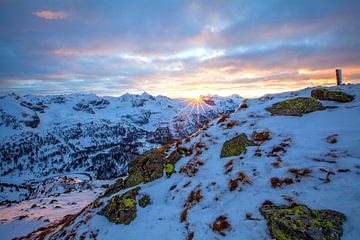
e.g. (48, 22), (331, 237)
(266, 97), (325, 117)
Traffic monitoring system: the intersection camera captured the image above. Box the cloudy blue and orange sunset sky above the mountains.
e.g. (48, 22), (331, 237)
(0, 0), (360, 97)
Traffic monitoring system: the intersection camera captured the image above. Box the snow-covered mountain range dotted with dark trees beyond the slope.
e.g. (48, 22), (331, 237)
(0, 92), (243, 179)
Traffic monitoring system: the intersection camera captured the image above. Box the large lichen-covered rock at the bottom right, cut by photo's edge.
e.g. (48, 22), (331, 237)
(260, 201), (345, 240)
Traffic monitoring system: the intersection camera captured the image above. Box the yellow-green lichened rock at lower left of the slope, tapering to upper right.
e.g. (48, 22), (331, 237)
(99, 187), (140, 224)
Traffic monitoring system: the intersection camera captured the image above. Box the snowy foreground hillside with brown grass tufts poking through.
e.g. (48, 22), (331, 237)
(0, 85), (360, 240)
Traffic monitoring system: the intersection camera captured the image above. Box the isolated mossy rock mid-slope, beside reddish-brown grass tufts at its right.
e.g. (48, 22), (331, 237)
(220, 133), (255, 158)
